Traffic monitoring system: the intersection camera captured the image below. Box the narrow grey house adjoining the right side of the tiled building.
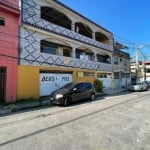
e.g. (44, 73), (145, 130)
(113, 42), (131, 88)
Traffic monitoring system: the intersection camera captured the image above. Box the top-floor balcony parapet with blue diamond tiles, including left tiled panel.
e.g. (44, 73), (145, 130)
(22, 1), (113, 51)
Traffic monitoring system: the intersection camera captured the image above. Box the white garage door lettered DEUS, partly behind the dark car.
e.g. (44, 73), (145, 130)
(40, 73), (72, 96)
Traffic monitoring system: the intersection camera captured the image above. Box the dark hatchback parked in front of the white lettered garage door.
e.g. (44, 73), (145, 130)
(50, 82), (95, 106)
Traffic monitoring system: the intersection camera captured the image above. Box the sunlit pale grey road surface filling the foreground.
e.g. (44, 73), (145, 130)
(0, 91), (150, 150)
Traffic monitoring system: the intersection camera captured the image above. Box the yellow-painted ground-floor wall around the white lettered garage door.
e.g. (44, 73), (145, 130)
(17, 65), (96, 100)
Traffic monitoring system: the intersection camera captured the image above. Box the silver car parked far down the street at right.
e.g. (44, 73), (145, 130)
(128, 81), (148, 91)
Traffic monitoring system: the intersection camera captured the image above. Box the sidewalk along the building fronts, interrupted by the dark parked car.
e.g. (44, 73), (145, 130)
(0, 88), (126, 116)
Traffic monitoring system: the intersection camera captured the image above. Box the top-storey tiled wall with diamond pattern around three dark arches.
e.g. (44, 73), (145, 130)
(22, 0), (113, 52)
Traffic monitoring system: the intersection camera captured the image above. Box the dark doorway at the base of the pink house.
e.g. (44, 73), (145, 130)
(0, 67), (6, 103)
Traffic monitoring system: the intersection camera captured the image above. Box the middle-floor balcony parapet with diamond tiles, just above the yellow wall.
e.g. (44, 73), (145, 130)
(20, 51), (112, 72)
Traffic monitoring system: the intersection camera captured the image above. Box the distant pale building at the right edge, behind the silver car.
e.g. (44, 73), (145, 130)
(130, 61), (150, 82)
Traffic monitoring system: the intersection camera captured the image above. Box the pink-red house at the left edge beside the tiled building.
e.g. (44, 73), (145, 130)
(0, 0), (20, 103)
